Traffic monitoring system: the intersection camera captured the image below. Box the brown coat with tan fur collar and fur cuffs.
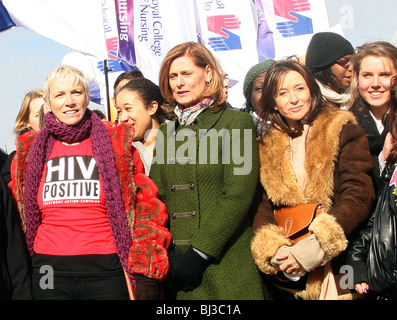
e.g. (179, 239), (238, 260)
(251, 108), (374, 299)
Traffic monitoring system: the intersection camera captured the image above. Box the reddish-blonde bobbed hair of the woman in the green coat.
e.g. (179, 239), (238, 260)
(159, 42), (227, 113)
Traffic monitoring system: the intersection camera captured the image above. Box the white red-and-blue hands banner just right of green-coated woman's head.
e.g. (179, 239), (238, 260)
(194, 0), (259, 108)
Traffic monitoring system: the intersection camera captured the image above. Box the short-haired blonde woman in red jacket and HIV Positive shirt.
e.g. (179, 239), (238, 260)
(11, 66), (170, 300)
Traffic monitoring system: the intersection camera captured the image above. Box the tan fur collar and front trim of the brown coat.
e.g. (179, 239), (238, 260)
(259, 108), (357, 210)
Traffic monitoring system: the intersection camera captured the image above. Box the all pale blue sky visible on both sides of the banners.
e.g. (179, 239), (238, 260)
(0, 0), (397, 152)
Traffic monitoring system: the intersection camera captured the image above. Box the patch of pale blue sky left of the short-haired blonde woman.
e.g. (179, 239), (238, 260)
(0, 28), (69, 152)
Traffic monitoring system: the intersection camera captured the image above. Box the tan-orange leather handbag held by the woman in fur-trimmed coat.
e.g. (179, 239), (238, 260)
(274, 203), (326, 242)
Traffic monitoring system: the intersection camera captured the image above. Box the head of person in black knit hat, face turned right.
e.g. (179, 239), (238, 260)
(306, 32), (354, 108)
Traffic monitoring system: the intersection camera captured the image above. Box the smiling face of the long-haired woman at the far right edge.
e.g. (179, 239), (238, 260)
(357, 56), (397, 113)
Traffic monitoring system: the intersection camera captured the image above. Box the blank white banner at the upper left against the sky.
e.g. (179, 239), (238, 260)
(3, 0), (107, 59)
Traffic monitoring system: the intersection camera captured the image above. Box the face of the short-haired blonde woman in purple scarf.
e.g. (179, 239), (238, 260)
(48, 78), (89, 126)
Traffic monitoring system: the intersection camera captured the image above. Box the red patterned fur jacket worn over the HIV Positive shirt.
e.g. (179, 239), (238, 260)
(9, 122), (171, 281)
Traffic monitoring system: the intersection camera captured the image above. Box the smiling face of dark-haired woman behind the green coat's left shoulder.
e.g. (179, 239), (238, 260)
(116, 89), (158, 140)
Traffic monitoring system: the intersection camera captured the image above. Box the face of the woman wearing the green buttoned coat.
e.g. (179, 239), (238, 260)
(169, 55), (212, 107)
